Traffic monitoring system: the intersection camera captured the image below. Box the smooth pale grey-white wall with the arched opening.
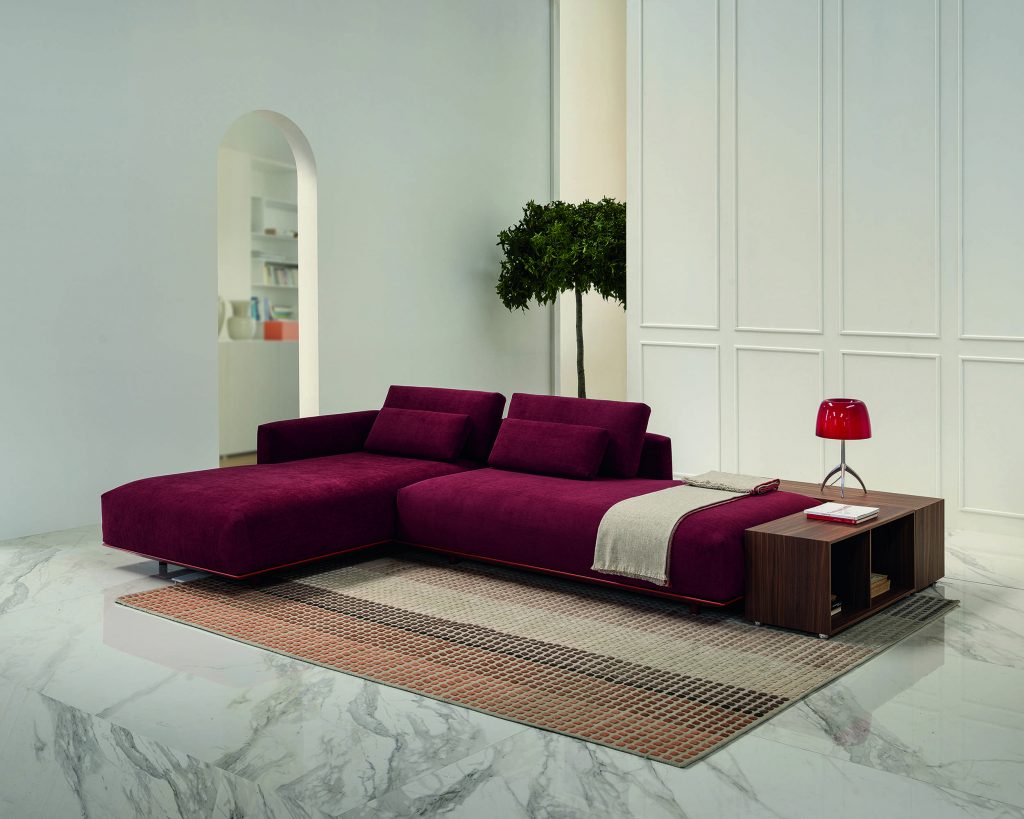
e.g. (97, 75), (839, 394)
(0, 0), (551, 537)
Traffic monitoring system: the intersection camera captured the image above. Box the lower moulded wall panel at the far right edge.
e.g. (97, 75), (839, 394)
(961, 358), (1024, 517)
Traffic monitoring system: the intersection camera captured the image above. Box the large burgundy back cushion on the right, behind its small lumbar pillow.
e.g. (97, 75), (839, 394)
(509, 392), (650, 478)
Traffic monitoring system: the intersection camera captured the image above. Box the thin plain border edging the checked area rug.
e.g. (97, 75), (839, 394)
(115, 554), (961, 768)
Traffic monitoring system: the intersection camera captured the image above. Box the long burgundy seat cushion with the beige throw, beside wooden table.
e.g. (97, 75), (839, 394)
(398, 469), (813, 602)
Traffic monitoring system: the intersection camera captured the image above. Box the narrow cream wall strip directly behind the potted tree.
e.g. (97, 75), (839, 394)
(558, 0), (626, 400)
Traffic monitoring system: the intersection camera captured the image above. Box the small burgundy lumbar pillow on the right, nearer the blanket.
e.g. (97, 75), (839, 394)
(487, 418), (608, 480)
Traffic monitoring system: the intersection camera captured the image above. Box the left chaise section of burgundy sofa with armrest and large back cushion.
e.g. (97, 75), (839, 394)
(100, 386), (505, 577)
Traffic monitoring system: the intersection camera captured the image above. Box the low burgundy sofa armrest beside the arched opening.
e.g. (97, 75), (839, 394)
(256, 410), (379, 464)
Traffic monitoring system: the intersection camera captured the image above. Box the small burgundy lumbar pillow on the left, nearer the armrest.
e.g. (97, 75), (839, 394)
(362, 407), (469, 461)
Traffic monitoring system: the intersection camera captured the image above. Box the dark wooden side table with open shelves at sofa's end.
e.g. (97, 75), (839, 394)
(745, 481), (945, 637)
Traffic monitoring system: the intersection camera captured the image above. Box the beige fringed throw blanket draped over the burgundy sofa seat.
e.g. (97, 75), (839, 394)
(592, 472), (778, 586)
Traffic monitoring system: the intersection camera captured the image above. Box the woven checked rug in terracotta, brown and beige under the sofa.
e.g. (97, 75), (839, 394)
(118, 553), (957, 766)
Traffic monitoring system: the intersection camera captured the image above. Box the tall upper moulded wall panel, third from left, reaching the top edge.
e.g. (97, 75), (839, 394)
(840, 0), (939, 335)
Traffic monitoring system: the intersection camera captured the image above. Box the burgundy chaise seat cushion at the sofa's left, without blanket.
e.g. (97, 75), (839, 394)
(101, 451), (468, 576)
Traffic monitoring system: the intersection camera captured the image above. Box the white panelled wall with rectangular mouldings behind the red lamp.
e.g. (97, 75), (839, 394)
(628, 0), (1024, 534)
